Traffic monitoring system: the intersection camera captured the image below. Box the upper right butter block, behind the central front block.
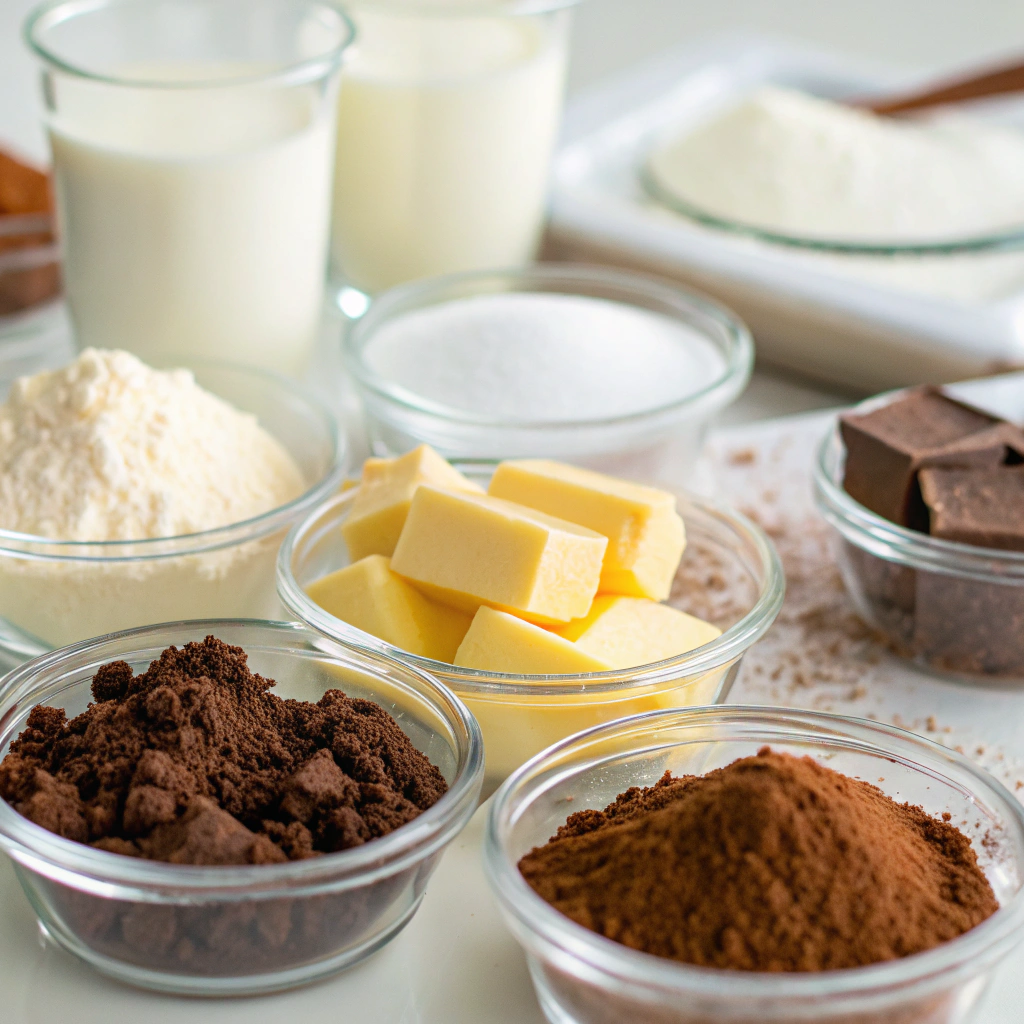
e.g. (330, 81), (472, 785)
(487, 459), (686, 601)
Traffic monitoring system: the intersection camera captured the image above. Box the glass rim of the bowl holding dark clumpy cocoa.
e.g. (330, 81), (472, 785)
(0, 618), (483, 888)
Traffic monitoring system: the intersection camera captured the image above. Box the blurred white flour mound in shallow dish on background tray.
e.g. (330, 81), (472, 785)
(648, 87), (1024, 242)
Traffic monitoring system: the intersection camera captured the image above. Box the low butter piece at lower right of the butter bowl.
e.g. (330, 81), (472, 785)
(553, 594), (722, 669)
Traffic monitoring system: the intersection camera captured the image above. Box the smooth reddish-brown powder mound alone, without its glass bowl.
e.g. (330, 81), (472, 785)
(519, 748), (998, 971)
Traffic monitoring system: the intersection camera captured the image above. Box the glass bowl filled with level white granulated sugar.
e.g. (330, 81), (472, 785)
(344, 264), (754, 481)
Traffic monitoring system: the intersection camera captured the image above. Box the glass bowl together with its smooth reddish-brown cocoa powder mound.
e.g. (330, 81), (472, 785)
(484, 707), (1024, 1024)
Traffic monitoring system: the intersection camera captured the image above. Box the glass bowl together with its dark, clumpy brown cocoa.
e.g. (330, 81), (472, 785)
(0, 620), (483, 995)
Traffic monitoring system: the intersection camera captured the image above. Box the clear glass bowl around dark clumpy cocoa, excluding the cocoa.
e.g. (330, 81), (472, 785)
(0, 620), (483, 995)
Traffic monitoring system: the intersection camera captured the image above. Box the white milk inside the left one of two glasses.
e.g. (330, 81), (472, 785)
(49, 69), (334, 373)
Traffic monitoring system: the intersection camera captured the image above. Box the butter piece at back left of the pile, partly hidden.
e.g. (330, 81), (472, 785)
(341, 444), (483, 562)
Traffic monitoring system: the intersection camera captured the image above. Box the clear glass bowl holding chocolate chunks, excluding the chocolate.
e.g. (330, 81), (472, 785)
(814, 405), (1024, 681)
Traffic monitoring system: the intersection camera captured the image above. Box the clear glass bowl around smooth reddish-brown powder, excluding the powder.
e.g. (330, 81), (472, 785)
(484, 707), (1024, 1024)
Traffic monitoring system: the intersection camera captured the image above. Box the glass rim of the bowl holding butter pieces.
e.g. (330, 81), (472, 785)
(278, 488), (785, 696)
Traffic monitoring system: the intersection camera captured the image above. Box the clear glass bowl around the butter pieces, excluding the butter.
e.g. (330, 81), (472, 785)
(278, 479), (785, 792)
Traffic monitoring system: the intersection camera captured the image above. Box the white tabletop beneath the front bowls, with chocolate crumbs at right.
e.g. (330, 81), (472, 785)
(6, 375), (1024, 1024)
